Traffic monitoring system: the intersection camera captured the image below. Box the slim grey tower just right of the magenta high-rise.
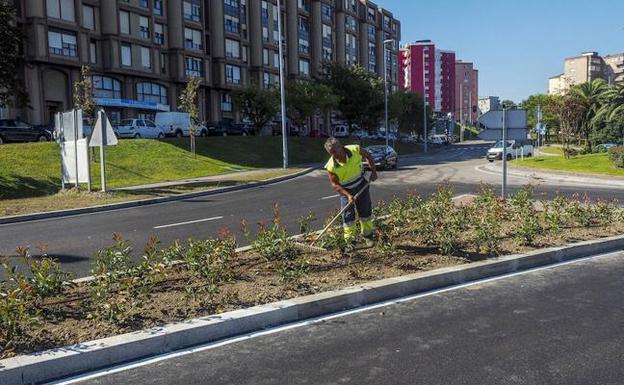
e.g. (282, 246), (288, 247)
(455, 60), (479, 124)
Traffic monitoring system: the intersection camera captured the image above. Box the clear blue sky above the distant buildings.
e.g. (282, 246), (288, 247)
(373, 0), (624, 102)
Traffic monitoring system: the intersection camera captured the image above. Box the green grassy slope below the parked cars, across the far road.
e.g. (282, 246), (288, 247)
(0, 136), (419, 199)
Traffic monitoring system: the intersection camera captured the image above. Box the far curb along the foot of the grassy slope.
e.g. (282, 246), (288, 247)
(0, 166), (320, 225)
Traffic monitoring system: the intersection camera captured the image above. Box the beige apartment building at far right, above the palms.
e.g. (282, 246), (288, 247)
(548, 52), (624, 95)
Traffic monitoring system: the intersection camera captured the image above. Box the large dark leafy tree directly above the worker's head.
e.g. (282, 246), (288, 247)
(324, 63), (384, 131)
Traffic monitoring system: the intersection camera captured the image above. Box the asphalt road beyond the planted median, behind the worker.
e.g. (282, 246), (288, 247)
(0, 144), (624, 276)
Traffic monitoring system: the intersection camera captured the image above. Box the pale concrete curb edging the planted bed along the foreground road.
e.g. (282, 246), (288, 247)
(0, 232), (624, 385)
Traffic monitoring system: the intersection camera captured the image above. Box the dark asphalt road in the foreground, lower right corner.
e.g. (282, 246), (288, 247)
(72, 248), (624, 385)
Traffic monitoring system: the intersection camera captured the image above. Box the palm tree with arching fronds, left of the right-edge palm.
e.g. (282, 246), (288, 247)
(570, 79), (607, 152)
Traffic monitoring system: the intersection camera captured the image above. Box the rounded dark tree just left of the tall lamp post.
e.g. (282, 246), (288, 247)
(232, 83), (280, 132)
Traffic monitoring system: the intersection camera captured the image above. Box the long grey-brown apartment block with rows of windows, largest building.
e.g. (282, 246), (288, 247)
(15, 0), (401, 124)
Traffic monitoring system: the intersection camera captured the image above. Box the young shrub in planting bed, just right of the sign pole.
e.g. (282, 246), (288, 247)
(510, 186), (541, 245)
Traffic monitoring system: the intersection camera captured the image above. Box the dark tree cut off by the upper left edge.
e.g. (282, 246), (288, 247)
(0, 0), (28, 107)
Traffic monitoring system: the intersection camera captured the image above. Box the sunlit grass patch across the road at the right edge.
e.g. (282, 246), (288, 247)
(512, 153), (624, 176)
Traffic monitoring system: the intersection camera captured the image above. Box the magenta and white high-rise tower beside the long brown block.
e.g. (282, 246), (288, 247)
(399, 40), (455, 115)
